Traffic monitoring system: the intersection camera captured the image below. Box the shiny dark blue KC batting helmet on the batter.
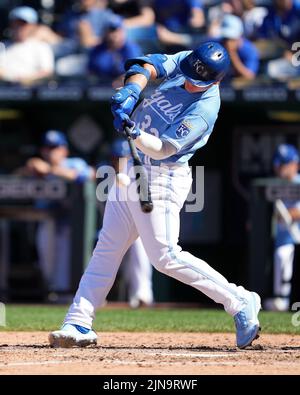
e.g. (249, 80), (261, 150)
(179, 41), (230, 87)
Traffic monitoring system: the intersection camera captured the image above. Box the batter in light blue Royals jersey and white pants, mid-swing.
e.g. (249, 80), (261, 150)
(49, 42), (260, 348)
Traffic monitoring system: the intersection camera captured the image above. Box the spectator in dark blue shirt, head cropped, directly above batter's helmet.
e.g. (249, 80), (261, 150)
(154, 0), (205, 50)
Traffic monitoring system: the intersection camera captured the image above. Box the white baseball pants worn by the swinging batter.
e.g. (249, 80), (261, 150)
(65, 165), (249, 328)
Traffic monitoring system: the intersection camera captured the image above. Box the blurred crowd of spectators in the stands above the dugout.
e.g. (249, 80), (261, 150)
(0, 0), (300, 85)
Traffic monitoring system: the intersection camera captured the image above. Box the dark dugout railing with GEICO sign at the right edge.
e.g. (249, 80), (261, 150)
(248, 178), (300, 305)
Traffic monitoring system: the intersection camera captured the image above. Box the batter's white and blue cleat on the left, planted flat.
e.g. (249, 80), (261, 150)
(49, 324), (97, 348)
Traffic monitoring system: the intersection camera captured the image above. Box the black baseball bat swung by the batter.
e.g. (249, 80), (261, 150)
(124, 126), (153, 213)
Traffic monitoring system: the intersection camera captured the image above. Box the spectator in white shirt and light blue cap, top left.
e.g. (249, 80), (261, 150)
(0, 7), (54, 83)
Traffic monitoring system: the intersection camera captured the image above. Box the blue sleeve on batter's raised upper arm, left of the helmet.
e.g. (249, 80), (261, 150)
(125, 51), (191, 79)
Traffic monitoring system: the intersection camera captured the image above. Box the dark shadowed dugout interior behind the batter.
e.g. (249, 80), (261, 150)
(0, 83), (300, 304)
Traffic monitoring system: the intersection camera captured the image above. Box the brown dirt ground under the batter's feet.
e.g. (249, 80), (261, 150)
(0, 332), (300, 375)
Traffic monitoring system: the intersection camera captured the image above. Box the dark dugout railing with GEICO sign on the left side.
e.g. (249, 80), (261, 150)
(0, 176), (96, 302)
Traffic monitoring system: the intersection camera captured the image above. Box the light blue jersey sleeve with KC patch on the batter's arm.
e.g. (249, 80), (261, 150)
(160, 114), (210, 152)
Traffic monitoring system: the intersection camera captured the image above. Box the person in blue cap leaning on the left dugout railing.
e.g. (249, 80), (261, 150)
(18, 130), (95, 300)
